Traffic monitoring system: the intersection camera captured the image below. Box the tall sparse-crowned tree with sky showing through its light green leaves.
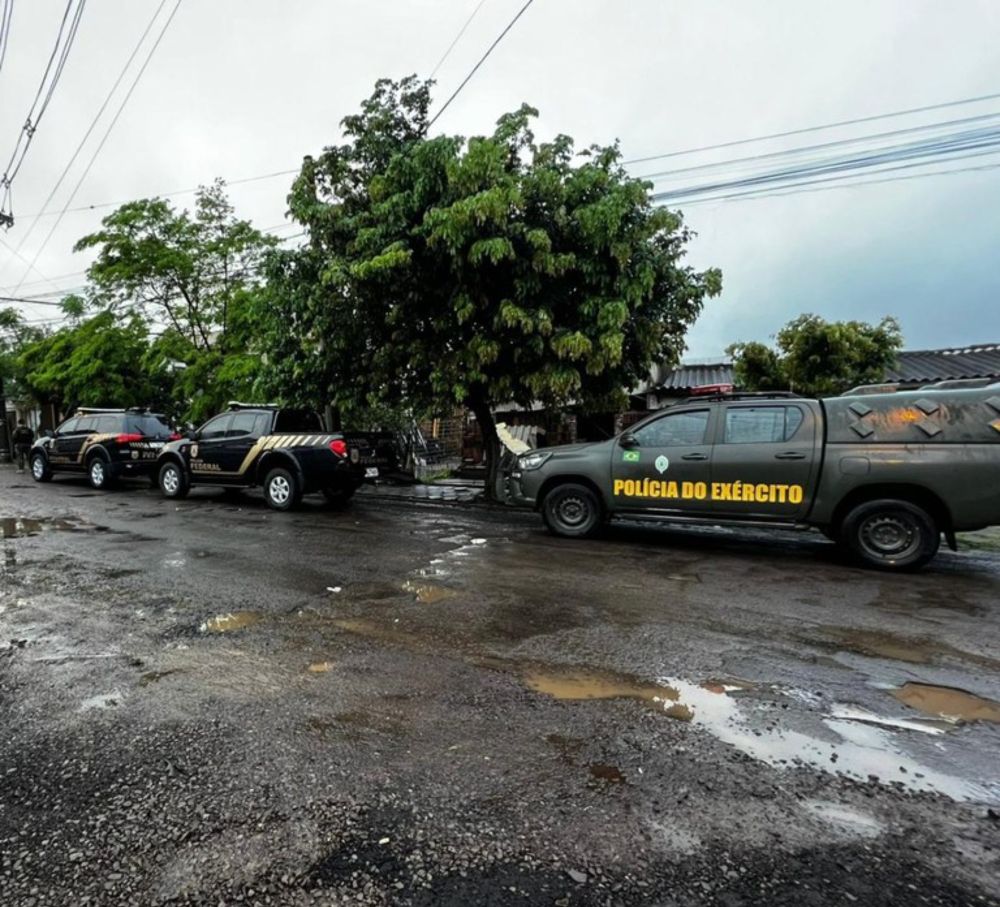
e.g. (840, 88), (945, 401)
(76, 180), (277, 421)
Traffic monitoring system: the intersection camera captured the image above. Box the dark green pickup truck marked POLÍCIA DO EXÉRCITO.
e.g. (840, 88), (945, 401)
(507, 384), (1000, 570)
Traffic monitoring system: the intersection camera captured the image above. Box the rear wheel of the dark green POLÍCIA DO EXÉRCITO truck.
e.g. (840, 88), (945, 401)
(840, 498), (941, 571)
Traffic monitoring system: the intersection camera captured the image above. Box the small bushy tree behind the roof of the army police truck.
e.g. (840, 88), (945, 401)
(727, 315), (903, 396)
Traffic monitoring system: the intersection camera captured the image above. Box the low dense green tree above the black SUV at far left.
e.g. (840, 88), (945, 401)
(16, 312), (169, 410)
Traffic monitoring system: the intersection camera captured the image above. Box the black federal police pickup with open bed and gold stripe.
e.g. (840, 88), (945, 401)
(158, 403), (379, 510)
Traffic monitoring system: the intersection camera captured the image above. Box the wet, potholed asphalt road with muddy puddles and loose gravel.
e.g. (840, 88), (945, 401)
(0, 467), (1000, 907)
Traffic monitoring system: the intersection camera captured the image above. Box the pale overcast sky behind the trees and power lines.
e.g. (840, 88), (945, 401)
(0, 0), (1000, 358)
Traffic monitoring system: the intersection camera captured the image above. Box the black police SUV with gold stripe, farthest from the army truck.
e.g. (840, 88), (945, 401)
(30, 408), (180, 488)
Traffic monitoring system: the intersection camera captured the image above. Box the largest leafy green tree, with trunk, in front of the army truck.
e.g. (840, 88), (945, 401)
(262, 77), (721, 487)
